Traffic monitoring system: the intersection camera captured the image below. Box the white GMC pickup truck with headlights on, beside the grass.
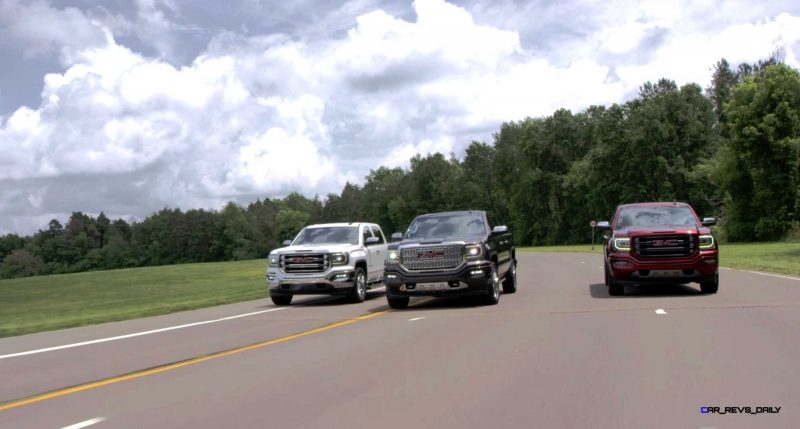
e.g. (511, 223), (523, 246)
(267, 222), (387, 305)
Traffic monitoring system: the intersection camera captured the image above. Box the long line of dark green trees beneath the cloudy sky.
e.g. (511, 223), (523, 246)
(0, 56), (800, 278)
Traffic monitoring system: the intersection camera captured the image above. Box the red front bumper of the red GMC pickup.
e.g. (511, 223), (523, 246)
(608, 249), (719, 284)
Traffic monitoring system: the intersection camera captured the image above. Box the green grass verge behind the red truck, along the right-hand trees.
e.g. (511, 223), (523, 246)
(519, 242), (800, 276)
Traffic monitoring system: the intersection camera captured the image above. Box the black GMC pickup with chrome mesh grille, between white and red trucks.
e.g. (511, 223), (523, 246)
(383, 211), (517, 308)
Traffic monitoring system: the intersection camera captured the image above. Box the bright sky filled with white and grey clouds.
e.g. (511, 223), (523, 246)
(0, 0), (800, 235)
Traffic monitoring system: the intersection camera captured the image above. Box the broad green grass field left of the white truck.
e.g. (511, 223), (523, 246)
(0, 259), (269, 337)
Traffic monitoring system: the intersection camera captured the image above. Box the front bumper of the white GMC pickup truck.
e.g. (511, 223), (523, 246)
(267, 267), (355, 295)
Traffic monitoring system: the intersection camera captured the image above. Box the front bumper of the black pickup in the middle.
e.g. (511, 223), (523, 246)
(383, 261), (492, 296)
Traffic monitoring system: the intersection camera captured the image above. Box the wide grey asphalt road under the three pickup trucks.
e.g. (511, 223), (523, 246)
(0, 253), (800, 429)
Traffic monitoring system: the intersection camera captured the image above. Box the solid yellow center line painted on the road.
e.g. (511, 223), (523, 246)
(0, 310), (389, 411)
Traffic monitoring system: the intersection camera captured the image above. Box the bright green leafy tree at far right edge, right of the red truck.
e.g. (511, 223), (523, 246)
(721, 64), (800, 240)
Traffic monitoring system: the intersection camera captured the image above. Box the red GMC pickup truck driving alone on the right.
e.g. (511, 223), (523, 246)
(597, 202), (719, 295)
